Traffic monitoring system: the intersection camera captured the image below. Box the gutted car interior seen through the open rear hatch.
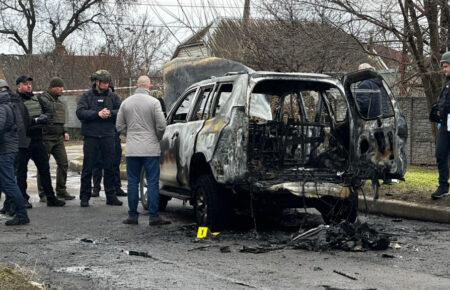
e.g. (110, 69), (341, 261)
(249, 79), (350, 180)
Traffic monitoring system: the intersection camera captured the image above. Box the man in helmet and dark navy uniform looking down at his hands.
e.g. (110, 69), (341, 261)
(77, 70), (122, 207)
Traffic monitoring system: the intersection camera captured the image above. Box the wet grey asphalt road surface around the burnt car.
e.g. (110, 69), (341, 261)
(0, 148), (450, 289)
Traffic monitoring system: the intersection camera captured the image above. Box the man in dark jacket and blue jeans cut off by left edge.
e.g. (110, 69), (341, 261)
(0, 80), (30, 226)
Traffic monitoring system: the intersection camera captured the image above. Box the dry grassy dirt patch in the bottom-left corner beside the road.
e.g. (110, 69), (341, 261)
(0, 265), (45, 290)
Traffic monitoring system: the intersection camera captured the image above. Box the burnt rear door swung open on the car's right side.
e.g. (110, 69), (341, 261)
(342, 70), (407, 180)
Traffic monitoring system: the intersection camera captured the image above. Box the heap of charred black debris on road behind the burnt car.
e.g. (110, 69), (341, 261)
(291, 222), (390, 251)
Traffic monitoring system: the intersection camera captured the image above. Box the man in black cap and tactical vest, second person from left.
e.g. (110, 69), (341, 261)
(16, 75), (65, 206)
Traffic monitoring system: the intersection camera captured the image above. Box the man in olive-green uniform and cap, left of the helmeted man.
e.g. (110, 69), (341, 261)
(38, 77), (75, 200)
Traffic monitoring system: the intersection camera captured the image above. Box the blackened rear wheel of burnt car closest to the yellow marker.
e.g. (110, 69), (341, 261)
(193, 174), (231, 231)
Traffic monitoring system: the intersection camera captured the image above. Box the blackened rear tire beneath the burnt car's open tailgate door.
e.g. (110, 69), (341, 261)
(316, 191), (358, 224)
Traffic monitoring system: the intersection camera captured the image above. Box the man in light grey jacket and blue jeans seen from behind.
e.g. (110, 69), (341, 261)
(116, 76), (170, 226)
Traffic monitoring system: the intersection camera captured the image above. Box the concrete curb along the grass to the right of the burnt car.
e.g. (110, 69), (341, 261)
(358, 197), (450, 224)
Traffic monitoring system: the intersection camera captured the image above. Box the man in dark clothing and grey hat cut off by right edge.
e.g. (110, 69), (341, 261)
(430, 51), (450, 199)
